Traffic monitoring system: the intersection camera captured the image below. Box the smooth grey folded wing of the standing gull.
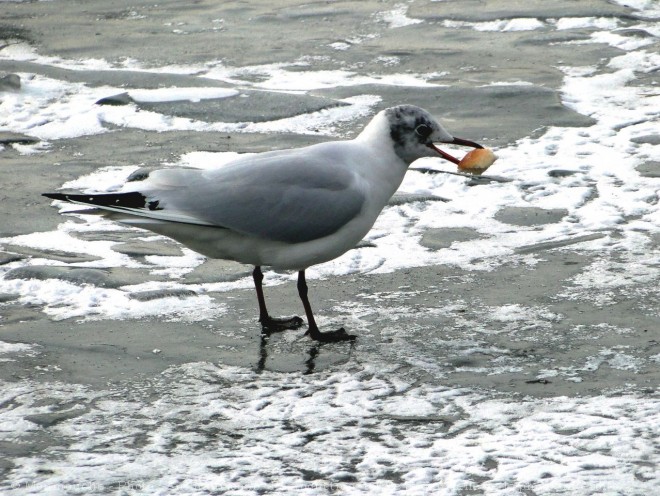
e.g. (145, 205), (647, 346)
(156, 154), (365, 243)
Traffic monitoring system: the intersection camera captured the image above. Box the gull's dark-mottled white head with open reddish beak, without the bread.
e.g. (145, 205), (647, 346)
(361, 105), (483, 165)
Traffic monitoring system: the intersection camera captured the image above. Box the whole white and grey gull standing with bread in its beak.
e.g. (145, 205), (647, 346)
(44, 105), (483, 342)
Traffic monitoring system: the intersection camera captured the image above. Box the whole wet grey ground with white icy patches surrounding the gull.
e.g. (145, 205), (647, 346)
(0, 0), (660, 495)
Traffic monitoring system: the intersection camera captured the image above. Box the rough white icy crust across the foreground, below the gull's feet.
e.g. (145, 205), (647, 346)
(0, 355), (660, 495)
